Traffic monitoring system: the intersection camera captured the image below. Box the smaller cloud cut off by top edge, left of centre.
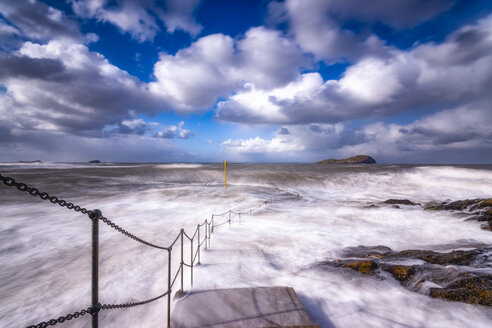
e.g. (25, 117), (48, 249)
(71, 0), (202, 42)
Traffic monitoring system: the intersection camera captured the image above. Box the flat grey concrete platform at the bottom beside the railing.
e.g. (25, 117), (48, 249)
(171, 287), (319, 328)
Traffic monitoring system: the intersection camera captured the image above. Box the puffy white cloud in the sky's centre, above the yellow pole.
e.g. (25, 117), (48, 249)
(150, 27), (306, 112)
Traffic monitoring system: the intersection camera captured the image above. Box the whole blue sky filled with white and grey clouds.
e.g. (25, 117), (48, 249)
(0, 0), (492, 164)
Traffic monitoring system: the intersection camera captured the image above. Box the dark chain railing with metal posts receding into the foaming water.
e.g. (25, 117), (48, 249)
(0, 174), (272, 328)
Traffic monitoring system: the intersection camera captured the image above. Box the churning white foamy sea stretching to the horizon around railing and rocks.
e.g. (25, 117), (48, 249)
(0, 163), (492, 328)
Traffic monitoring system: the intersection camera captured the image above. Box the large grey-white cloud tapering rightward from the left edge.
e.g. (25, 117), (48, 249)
(0, 39), (166, 134)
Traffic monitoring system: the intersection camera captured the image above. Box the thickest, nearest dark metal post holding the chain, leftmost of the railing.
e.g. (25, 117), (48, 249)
(90, 210), (102, 328)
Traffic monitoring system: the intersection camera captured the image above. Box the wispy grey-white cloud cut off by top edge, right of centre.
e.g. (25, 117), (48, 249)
(269, 0), (454, 62)
